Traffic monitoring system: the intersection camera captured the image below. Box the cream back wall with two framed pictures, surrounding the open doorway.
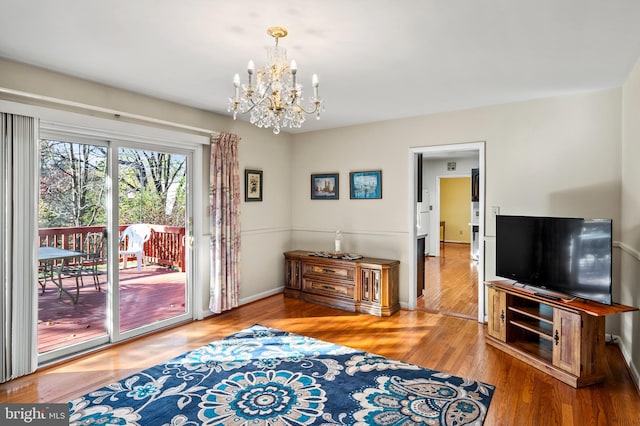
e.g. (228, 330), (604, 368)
(291, 89), (621, 312)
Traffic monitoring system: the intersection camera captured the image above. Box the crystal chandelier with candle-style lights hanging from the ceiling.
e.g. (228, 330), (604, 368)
(227, 27), (324, 134)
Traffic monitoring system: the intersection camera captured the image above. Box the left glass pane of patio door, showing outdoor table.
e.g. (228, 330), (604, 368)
(38, 139), (108, 353)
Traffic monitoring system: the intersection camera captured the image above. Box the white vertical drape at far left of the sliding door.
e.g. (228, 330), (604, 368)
(0, 112), (38, 382)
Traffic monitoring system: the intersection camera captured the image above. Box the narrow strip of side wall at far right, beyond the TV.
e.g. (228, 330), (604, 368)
(615, 56), (640, 384)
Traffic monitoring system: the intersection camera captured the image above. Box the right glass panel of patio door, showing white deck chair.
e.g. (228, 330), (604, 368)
(117, 147), (189, 333)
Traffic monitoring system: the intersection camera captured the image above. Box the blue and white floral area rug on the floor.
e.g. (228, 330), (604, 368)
(69, 325), (494, 426)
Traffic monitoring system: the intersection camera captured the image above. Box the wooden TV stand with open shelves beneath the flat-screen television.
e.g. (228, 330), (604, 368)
(485, 280), (638, 388)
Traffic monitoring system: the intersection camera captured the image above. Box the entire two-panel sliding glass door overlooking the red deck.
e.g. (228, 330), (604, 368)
(34, 131), (194, 362)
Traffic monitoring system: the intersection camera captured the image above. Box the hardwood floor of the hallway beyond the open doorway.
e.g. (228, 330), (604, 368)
(418, 243), (478, 320)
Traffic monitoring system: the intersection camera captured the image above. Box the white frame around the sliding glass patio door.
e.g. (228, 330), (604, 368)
(33, 111), (210, 365)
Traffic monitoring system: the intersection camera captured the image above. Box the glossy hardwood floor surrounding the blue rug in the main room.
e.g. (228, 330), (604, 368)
(0, 295), (640, 426)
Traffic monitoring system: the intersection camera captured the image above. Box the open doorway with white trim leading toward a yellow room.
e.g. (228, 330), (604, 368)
(410, 143), (485, 321)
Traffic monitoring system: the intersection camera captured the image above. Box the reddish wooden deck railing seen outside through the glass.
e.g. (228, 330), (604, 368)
(38, 224), (186, 271)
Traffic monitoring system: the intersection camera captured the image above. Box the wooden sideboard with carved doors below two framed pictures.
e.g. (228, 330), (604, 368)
(284, 250), (400, 316)
